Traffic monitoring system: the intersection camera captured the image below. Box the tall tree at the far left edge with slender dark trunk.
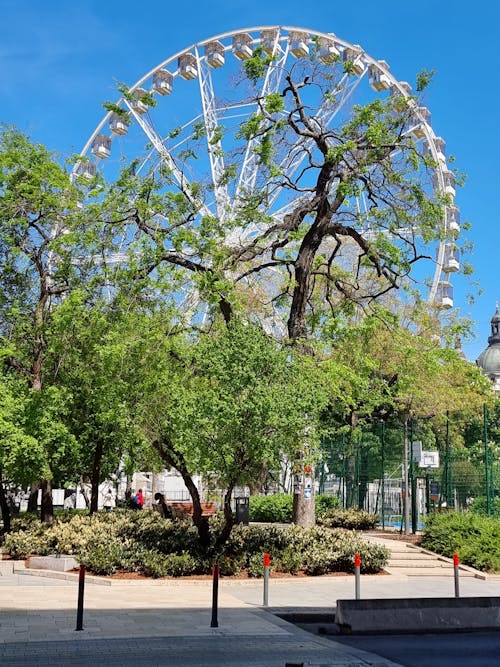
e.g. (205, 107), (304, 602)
(0, 127), (80, 520)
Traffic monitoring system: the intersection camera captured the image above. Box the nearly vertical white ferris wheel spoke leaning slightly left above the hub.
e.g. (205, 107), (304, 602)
(195, 49), (229, 221)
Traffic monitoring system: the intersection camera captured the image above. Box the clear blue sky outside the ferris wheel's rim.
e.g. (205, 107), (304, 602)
(0, 0), (500, 359)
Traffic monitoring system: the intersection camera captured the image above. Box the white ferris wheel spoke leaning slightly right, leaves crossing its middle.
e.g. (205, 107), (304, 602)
(234, 31), (288, 206)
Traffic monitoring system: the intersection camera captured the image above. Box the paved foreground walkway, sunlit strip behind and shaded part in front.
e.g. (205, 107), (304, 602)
(0, 536), (500, 667)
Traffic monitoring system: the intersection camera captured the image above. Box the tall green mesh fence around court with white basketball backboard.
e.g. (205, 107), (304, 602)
(319, 409), (500, 530)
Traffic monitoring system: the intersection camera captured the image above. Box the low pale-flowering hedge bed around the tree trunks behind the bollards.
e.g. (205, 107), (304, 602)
(4, 510), (388, 577)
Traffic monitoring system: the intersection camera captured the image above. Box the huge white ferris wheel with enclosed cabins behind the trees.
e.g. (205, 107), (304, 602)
(73, 26), (460, 326)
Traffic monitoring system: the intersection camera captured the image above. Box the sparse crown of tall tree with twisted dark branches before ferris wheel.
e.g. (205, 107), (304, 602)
(81, 49), (451, 528)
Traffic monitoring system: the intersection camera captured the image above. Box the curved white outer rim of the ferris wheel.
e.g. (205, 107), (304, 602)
(72, 24), (456, 310)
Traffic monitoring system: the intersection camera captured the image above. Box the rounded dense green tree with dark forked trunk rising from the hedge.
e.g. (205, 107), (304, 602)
(128, 319), (329, 552)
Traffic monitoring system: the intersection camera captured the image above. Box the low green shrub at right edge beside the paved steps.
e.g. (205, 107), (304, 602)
(422, 512), (500, 572)
